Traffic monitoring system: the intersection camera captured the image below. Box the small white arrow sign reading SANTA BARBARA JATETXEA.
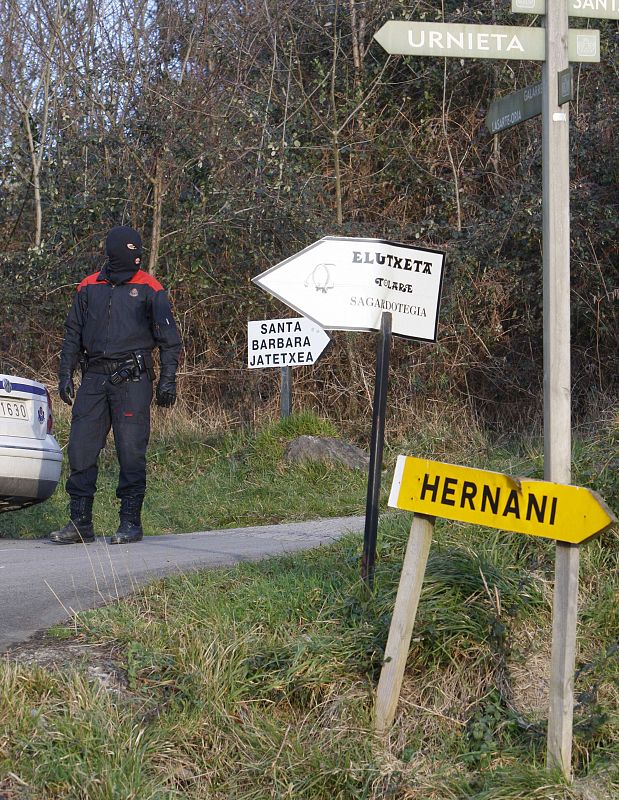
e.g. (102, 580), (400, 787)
(247, 317), (331, 369)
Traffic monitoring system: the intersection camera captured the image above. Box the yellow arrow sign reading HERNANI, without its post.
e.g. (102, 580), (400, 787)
(389, 456), (616, 544)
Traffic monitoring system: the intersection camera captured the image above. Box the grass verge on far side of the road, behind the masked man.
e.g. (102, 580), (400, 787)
(0, 414), (367, 538)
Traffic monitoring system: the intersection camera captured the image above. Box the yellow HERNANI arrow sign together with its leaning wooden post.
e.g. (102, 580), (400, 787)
(374, 456), (616, 734)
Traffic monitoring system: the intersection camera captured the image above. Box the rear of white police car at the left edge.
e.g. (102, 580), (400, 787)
(0, 373), (62, 511)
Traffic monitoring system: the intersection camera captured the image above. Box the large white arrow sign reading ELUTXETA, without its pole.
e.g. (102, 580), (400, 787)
(253, 236), (445, 342)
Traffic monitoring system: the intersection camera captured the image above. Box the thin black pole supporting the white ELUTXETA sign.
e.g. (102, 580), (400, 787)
(361, 311), (391, 589)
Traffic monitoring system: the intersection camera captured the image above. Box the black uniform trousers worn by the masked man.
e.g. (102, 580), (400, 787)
(66, 372), (153, 498)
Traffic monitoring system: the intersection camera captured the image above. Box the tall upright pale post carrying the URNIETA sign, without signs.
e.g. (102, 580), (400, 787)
(542, 0), (579, 778)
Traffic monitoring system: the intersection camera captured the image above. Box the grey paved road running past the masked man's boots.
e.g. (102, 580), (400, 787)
(0, 517), (364, 652)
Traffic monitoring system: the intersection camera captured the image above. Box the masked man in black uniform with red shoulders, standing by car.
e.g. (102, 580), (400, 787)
(50, 226), (181, 544)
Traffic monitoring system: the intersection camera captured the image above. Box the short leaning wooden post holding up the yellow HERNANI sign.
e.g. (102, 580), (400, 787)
(374, 514), (434, 734)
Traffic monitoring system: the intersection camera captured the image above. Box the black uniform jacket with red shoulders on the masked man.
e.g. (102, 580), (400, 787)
(60, 267), (181, 378)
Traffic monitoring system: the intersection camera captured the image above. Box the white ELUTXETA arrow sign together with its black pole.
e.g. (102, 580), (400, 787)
(253, 236), (445, 588)
